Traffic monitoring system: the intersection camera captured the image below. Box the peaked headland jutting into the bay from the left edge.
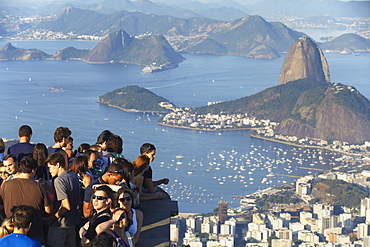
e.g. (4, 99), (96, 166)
(0, 30), (184, 72)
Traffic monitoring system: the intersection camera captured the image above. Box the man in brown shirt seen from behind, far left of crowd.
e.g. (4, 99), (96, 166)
(0, 156), (51, 243)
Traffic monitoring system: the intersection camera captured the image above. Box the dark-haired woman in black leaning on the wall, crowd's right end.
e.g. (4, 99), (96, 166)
(140, 143), (169, 194)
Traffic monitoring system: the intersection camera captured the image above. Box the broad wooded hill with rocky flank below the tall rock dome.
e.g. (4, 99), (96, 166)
(193, 79), (370, 143)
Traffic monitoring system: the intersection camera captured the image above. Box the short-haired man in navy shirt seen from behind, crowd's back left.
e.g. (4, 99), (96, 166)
(8, 125), (35, 160)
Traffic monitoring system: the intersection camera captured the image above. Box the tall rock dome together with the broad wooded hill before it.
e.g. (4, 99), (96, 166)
(193, 37), (370, 144)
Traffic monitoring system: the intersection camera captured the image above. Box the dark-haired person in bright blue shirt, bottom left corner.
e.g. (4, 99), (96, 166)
(0, 205), (41, 247)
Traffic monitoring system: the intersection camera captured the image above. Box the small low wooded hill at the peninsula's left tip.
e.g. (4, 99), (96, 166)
(99, 86), (176, 112)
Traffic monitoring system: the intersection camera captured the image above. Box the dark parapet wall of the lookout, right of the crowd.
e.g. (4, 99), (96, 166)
(135, 188), (179, 247)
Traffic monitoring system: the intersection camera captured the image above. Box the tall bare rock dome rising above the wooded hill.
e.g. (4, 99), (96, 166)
(279, 37), (330, 85)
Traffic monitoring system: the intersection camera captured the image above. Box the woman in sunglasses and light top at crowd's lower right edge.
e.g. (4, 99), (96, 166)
(116, 188), (144, 244)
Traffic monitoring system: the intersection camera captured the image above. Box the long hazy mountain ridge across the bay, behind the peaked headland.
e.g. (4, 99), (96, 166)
(38, 8), (304, 58)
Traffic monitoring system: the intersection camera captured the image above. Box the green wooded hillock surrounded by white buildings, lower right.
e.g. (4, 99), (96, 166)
(312, 179), (368, 208)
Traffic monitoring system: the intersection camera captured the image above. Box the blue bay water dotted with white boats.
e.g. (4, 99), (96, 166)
(0, 41), (370, 212)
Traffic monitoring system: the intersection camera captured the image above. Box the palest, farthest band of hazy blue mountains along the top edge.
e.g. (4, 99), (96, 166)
(2, 0), (370, 21)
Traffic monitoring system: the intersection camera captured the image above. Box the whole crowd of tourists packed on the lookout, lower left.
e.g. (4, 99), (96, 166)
(0, 125), (169, 247)
